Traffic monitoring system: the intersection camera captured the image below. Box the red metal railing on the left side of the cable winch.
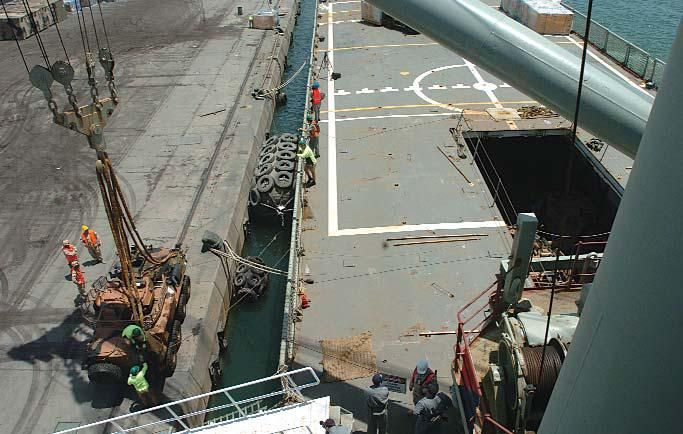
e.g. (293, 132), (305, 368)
(453, 280), (513, 434)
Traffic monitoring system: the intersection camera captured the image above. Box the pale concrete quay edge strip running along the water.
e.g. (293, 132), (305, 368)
(159, 0), (298, 424)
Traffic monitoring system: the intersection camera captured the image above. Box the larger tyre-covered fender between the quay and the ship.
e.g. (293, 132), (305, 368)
(249, 133), (299, 215)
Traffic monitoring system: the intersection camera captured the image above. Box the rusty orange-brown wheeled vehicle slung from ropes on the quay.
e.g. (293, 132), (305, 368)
(83, 246), (191, 384)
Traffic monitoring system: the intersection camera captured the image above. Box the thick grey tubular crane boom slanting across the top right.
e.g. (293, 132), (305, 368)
(368, 0), (653, 157)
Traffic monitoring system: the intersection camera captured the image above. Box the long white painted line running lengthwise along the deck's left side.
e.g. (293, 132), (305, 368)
(327, 3), (339, 233)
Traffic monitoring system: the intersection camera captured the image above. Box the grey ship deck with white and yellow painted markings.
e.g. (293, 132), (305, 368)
(295, 1), (649, 433)
